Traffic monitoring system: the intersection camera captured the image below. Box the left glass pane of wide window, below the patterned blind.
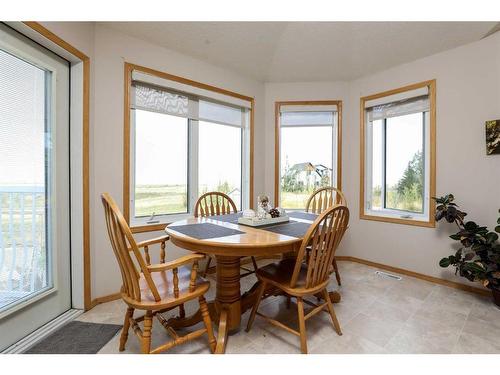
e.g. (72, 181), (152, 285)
(134, 110), (188, 217)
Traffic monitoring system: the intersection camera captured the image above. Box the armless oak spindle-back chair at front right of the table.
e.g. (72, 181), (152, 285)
(247, 205), (349, 353)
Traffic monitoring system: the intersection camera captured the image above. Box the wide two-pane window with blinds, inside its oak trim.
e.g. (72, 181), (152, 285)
(125, 65), (252, 226)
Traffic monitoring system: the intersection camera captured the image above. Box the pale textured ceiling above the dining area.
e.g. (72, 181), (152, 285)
(100, 22), (496, 82)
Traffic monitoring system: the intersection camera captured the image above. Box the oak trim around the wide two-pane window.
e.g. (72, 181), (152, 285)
(123, 62), (255, 233)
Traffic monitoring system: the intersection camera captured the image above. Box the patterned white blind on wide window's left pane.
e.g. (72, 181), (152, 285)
(132, 83), (189, 117)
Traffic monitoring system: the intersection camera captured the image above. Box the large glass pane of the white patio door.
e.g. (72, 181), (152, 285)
(0, 50), (51, 309)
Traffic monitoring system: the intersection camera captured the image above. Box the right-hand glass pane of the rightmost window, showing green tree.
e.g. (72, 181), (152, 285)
(386, 113), (424, 212)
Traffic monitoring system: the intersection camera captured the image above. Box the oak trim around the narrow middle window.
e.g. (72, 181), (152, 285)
(274, 100), (342, 205)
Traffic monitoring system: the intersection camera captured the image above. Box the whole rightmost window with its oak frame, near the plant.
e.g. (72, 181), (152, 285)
(361, 81), (435, 226)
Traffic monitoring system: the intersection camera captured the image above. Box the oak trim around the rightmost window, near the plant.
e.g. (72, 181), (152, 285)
(359, 79), (436, 228)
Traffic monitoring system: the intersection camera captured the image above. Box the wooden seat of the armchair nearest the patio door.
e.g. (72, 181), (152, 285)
(133, 266), (210, 305)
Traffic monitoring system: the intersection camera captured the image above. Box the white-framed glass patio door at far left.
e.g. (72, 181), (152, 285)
(0, 24), (71, 351)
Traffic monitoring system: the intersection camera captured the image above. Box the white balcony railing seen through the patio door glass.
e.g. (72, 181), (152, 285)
(0, 186), (47, 309)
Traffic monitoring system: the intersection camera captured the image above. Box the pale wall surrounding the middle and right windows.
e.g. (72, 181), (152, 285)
(266, 33), (500, 283)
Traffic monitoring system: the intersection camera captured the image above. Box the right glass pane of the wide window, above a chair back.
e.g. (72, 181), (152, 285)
(198, 121), (242, 210)
